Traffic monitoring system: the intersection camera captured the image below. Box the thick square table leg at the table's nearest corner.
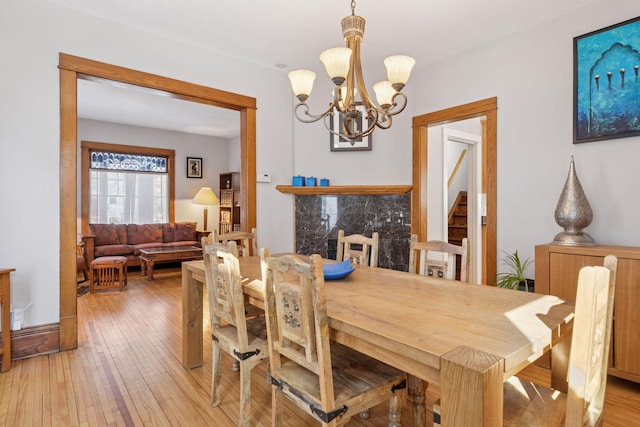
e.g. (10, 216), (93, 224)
(440, 346), (504, 427)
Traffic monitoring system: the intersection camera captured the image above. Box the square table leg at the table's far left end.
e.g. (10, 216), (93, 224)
(182, 262), (203, 369)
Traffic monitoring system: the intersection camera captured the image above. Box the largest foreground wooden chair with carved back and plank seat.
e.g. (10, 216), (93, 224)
(261, 248), (406, 426)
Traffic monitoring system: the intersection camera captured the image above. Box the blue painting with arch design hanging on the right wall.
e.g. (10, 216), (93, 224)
(573, 17), (640, 144)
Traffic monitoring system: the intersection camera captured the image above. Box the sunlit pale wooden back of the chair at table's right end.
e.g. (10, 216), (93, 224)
(566, 255), (617, 427)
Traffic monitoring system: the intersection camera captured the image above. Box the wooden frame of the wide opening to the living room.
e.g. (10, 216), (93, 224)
(58, 53), (257, 351)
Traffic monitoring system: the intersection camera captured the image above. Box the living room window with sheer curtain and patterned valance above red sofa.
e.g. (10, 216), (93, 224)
(82, 142), (174, 229)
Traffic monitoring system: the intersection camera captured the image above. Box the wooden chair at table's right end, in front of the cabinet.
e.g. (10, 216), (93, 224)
(434, 255), (617, 427)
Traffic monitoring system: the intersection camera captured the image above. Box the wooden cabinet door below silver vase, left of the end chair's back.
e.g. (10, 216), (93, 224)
(549, 253), (603, 301)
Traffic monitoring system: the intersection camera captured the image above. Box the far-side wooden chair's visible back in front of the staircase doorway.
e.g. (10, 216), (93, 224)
(409, 234), (469, 282)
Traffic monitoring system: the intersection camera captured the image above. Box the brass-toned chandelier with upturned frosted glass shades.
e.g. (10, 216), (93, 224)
(289, 0), (416, 143)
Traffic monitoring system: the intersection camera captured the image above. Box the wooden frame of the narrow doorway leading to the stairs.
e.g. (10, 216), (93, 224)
(411, 97), (498, 285)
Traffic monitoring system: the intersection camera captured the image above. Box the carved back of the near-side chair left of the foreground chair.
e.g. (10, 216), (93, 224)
(202, 241), (248, 352)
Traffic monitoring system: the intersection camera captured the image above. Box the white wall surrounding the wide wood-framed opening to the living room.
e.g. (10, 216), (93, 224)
(0, 0), (293, 326)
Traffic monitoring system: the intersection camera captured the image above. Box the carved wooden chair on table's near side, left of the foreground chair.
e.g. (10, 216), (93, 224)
(203, 238), (269, 427)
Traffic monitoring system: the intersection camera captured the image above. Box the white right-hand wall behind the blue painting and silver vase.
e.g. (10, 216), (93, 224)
(410, 0), (640, 276)
